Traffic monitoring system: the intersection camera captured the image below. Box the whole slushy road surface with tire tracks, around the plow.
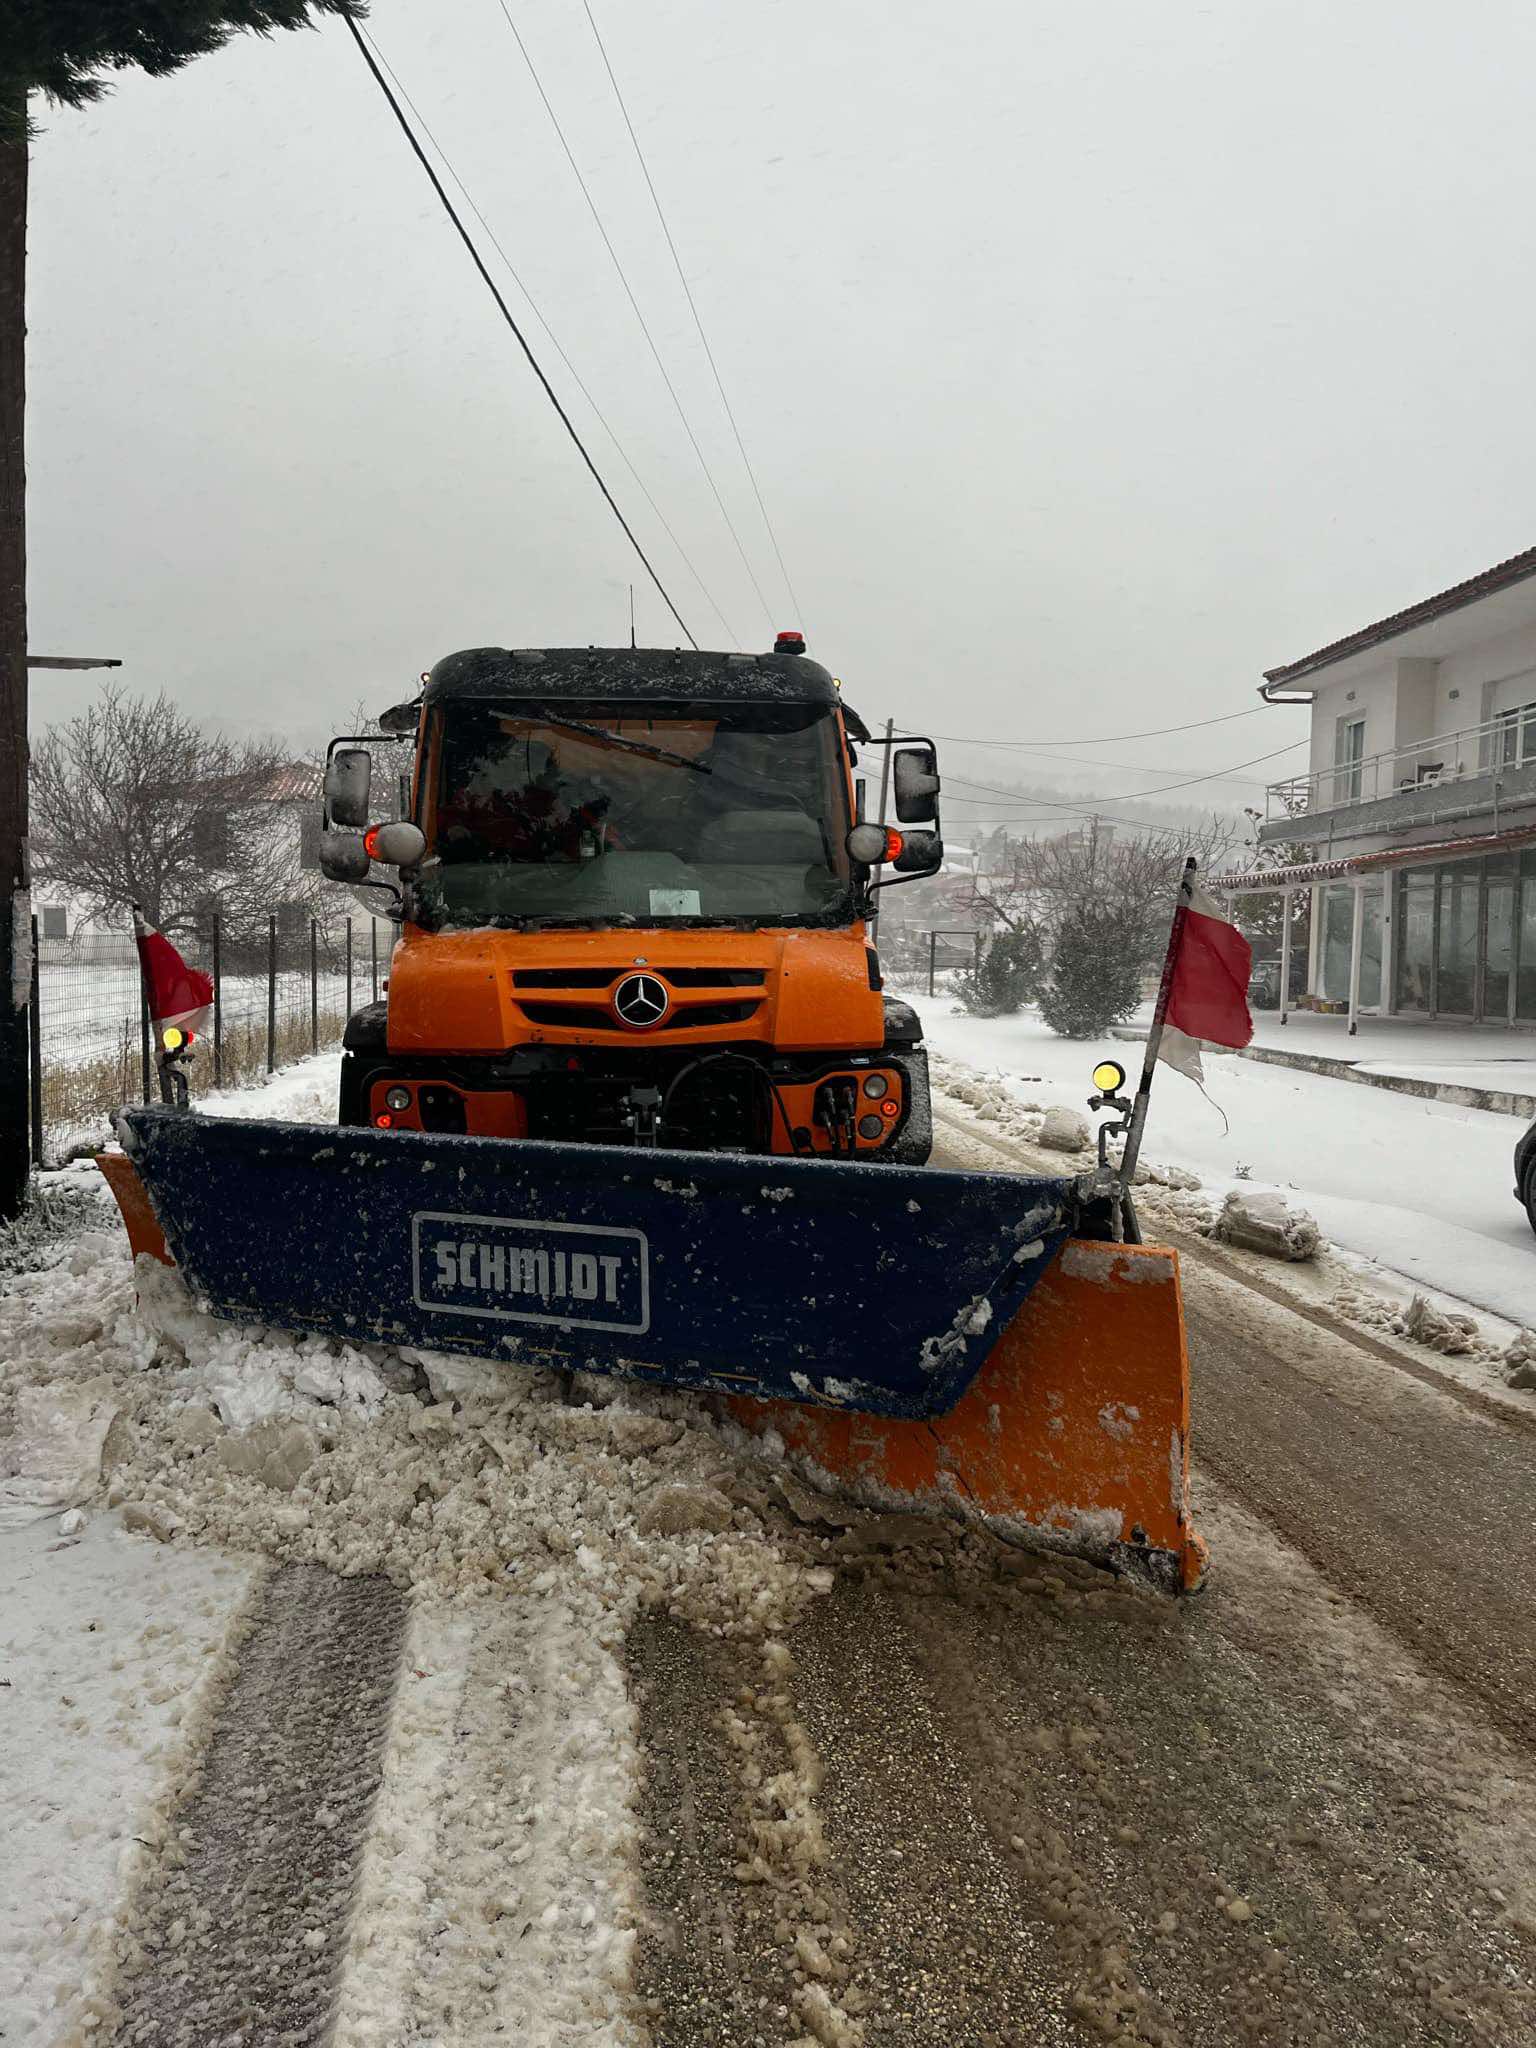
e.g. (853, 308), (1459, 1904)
(0, 1061), (1536, 2048)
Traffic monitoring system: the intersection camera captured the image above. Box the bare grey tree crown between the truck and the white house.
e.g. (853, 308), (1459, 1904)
(975, 817), (1241, 971)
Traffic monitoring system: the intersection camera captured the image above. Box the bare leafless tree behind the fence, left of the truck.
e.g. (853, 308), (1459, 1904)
(31, 688), (324, 944)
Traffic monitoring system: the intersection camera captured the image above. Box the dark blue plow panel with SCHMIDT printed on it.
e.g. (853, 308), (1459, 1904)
(117, 1108), (1077, 1417)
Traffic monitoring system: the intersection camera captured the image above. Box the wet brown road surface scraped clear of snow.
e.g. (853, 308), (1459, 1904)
(96, 1112), (1536, 2048)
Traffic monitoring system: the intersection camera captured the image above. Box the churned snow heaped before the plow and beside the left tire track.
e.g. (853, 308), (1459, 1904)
(0, 1055), (856, 2048)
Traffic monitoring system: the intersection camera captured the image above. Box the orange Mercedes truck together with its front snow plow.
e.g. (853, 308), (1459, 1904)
(102, 633), (1204, 1591)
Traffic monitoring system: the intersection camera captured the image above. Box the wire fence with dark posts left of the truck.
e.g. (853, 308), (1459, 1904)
(33, 913), (395, 1163)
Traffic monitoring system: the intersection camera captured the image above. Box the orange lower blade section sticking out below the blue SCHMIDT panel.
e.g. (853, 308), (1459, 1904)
(727, 1239), (1206, 1593)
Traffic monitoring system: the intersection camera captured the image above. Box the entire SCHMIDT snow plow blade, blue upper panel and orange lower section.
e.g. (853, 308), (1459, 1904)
(100, 1108), (1198, 1585)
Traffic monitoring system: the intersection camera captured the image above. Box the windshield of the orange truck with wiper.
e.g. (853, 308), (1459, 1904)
(420, 702), (852, 926)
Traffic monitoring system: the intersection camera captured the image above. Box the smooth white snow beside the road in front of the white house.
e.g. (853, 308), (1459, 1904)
(909, 995), (1536, 1325)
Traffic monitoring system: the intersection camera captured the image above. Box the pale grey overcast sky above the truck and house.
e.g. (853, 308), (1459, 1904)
(29, 0), (1536, 823)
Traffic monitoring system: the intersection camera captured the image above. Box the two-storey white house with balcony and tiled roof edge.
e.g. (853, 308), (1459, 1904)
(1219, 549), (1536, 1030)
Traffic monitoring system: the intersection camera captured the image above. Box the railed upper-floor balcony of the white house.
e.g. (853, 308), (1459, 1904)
(1257, 713), (1536, 848)
